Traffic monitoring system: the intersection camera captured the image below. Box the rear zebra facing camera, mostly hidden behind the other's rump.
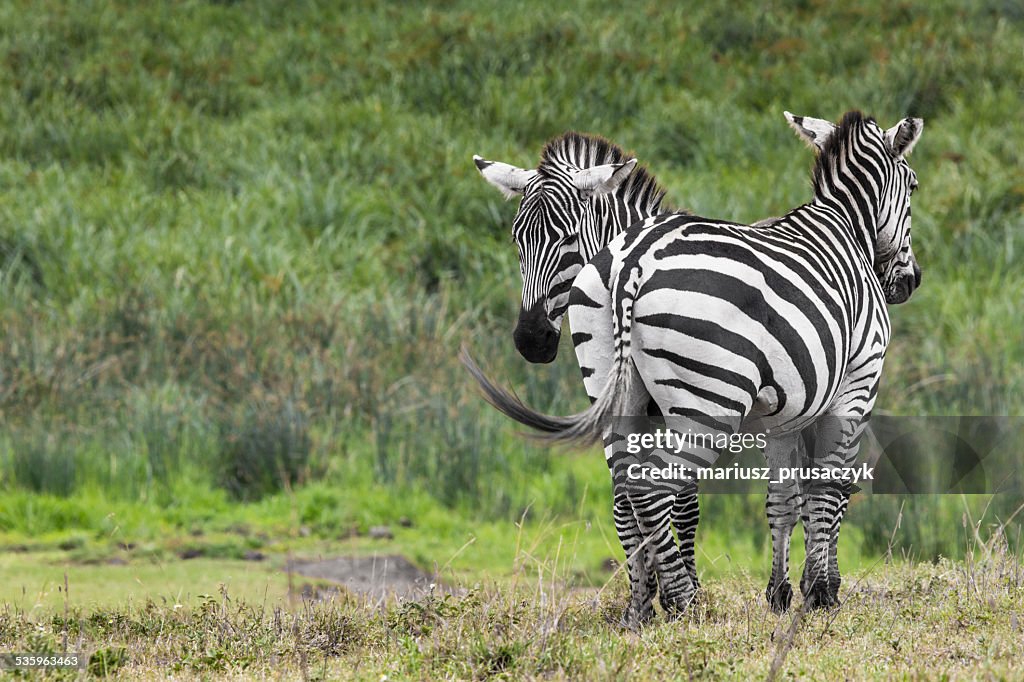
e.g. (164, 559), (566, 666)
(473, 131), (790, 622)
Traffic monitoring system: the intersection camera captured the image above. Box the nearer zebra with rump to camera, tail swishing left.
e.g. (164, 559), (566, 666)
(464, 111), (924, 626)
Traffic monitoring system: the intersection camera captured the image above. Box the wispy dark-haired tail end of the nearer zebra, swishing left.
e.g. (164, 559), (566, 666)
(459, 346), (632, 447)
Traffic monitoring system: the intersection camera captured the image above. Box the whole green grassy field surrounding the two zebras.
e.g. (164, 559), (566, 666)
(0, 0), (1024, 677)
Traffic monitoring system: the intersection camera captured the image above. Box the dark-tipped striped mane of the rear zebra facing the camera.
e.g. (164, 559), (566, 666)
(537, 130), (670, 213)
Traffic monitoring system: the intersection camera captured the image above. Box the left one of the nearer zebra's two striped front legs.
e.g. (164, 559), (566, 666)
(765, 432), (802, 613)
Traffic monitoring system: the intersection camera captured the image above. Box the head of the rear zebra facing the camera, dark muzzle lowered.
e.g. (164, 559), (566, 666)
(473, 133), (647, 363)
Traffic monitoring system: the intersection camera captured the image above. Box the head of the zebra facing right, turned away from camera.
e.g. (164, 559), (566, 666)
(785, 112), (925, 303)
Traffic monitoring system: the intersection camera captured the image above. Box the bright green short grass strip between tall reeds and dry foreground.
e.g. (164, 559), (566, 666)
(0, 475), (880, 610)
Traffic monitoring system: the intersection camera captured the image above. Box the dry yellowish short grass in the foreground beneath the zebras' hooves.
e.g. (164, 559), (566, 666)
(0, 534), (1024, 680)
